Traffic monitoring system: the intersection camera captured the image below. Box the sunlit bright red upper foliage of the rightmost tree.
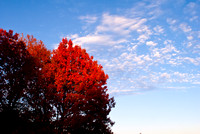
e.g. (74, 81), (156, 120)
(52, 39), (108, 95)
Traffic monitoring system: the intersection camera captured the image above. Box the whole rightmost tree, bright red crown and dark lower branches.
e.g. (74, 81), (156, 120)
(51, 39), (115, 133)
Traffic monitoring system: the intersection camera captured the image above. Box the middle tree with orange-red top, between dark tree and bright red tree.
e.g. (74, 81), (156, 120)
(20, 35), (56, 133)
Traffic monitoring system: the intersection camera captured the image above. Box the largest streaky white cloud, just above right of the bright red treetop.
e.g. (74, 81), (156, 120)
(71, 13), (147, 46)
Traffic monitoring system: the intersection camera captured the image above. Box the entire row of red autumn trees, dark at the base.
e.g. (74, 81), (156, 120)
(0, 29), (115, 134)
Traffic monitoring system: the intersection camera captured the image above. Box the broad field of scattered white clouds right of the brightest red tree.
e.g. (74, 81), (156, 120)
(63, 0), (200, 95)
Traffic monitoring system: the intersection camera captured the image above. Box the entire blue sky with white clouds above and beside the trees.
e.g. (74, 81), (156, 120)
(0, 0), (200, 134)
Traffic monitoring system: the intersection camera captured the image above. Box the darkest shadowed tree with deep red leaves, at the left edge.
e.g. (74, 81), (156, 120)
(0, 29), (35, 133)
